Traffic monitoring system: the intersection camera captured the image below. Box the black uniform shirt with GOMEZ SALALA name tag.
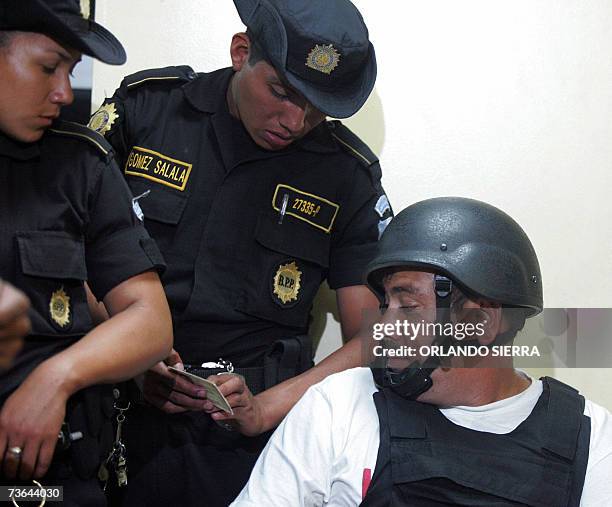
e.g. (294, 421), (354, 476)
(95, 67), (391, 366)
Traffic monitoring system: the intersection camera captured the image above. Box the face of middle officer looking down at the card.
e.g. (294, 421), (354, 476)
(228, 36), (325, 151)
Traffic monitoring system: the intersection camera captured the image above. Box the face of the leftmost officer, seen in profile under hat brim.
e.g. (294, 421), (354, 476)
(0, 32), (81, 143)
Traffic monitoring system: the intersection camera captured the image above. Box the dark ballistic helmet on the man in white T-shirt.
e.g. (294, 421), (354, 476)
(366, 197), (543, 317)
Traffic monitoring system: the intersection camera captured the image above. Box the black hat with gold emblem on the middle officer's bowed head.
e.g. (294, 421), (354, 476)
(234, 0), (376, 118)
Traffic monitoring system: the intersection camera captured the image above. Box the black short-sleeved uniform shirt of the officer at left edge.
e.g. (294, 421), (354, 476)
(0, 122), (163, 402)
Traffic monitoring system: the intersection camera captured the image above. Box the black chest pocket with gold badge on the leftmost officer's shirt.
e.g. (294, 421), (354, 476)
(16, 231), (92, 336)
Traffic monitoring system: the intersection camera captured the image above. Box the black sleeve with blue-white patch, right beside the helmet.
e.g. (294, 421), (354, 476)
(328, 163), (393, 289)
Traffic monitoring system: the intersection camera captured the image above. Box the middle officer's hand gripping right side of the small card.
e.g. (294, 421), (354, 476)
(204, 373), (263, 437)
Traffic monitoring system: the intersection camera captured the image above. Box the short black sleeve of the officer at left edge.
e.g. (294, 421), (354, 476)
(86, 161), (165, 300)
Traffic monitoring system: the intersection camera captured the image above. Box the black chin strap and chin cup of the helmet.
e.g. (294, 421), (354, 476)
(372, 275), (453, 400)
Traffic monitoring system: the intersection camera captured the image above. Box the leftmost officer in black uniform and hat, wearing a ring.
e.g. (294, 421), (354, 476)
(0, 0), (172, 505)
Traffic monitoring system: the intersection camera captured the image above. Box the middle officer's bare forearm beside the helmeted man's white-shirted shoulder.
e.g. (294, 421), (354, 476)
(255, 337), (361, 432)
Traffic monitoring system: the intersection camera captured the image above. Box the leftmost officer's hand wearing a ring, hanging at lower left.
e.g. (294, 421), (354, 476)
(0, 363), (69, 480)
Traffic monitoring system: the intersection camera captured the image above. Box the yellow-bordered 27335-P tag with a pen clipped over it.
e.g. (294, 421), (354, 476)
(272, 185), (340, 234)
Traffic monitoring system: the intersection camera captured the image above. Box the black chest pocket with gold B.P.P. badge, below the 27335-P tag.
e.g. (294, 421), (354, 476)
(236, 212), (330, 328)
